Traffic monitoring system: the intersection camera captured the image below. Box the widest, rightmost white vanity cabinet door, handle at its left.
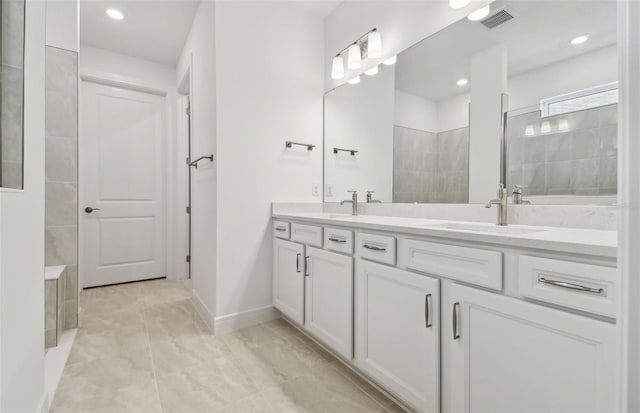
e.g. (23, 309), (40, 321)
(442, 285), (617, 413)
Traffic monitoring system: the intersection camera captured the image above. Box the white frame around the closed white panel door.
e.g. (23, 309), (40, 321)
(78, 70), (175, 292)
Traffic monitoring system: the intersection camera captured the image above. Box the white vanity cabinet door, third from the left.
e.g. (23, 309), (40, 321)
(356, 260), (440, 412)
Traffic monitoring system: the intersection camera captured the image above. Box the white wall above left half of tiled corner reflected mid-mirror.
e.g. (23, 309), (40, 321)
(394, 90), (439, 133)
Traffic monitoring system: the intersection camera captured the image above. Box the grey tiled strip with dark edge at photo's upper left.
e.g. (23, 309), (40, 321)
(0, 0), (24, 189)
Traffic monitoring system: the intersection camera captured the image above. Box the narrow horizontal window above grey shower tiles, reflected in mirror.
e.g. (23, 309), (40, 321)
(540, 82), (618, 117)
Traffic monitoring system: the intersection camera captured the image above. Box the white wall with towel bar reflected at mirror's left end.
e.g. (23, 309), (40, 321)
(324, 66), (398, 202)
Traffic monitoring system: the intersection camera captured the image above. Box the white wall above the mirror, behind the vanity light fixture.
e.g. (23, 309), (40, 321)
(324, 0), (492, 91)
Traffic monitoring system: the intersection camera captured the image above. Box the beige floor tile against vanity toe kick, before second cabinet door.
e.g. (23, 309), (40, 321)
(235, 336), (326, 389)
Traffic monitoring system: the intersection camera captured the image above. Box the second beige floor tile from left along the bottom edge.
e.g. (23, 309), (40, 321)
(157, 356), (256, 412)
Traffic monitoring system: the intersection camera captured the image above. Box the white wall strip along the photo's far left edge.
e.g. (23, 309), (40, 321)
(0, 1), (48, 412)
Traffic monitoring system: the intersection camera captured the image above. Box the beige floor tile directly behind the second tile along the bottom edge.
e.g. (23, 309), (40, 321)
(151, 335), (231, 376)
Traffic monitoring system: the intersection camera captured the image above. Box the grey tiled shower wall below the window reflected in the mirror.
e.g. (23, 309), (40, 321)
(507, 105), (618, 196)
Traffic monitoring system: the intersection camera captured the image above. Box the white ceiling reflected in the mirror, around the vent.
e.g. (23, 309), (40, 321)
(396, 0), (616, 102)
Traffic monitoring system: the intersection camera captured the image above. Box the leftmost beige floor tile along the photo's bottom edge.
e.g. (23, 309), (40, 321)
(50, 379), (162, 413)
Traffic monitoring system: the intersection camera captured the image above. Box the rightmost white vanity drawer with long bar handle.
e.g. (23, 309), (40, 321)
(518, 255), (618, 317)
